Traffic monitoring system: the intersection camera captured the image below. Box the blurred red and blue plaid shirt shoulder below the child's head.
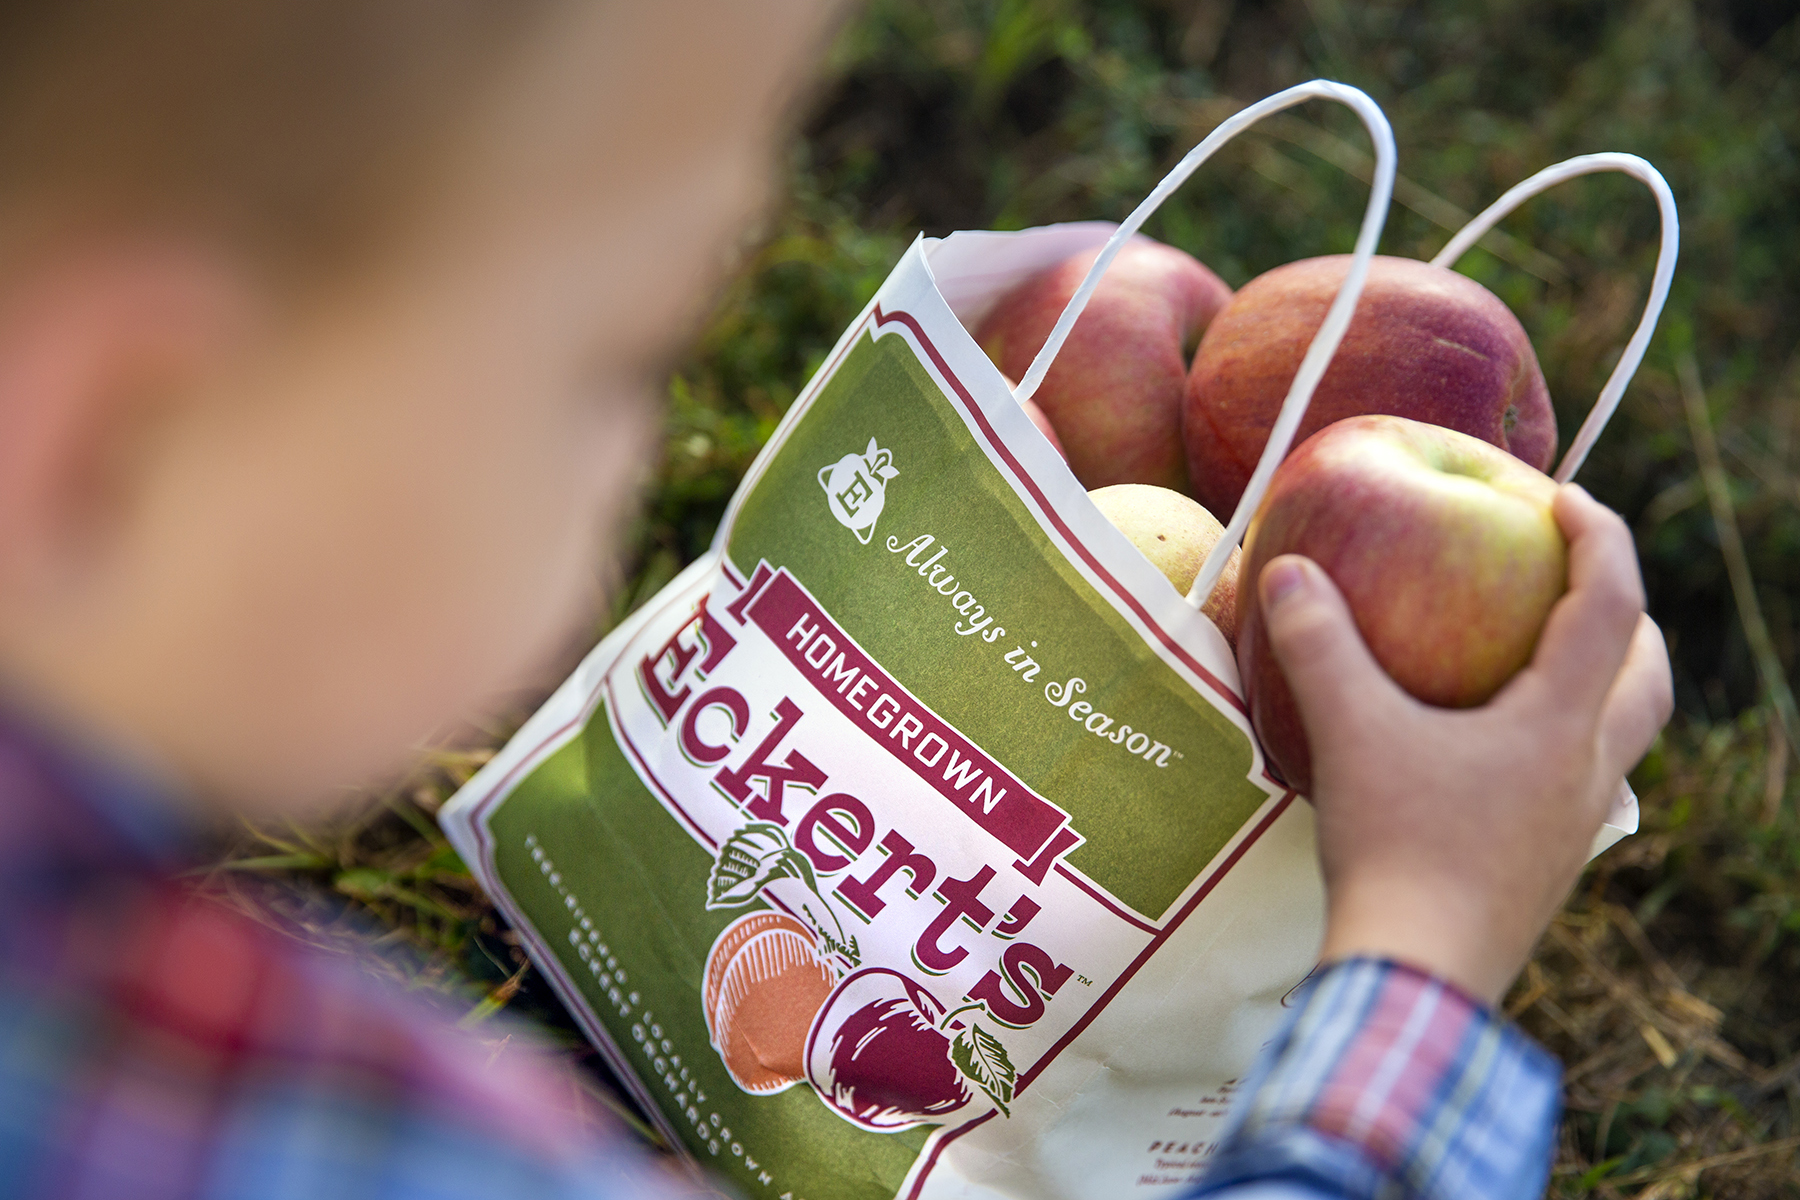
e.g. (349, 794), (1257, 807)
(0, 723), (691, 1200)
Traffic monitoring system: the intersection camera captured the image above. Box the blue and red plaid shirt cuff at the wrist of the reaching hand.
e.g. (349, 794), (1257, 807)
(1192, 959), (1562, 1200)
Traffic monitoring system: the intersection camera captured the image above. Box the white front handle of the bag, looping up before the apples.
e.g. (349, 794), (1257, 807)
(1013, 79), (1397, 608)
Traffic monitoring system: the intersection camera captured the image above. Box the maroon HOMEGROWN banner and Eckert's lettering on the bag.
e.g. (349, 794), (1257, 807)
(635, 565), (1080, 1027)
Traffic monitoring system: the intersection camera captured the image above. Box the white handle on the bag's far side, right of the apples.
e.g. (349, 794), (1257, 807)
(1431, 153), (1681, 484)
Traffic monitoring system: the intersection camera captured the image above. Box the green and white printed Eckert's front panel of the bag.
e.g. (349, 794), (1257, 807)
(450, 275), (1287, 1200)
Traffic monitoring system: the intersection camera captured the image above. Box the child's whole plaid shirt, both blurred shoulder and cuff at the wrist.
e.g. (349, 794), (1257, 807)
(0, 723), (1557, 1200)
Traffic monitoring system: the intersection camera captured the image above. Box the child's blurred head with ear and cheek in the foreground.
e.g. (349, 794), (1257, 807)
(0, 0), (833, 808)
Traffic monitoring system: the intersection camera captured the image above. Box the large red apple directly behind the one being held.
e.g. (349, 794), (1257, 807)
(1183, 255), (1557, 520)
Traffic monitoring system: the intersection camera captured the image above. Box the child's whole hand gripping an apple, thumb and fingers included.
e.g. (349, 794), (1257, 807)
(1260, 486), (1672, 1002)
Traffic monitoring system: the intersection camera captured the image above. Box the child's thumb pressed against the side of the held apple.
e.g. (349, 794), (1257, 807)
(1256, 554), (1397, 734)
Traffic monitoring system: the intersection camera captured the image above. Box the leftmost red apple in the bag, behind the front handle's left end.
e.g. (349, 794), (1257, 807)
(976, 237), (1231, 491)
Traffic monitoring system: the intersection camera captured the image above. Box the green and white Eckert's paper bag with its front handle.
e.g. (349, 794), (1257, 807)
(443, 83), (1670, 1200)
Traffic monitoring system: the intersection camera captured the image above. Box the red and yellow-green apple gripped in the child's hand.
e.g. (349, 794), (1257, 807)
(1238, 416), (1568, 792)
